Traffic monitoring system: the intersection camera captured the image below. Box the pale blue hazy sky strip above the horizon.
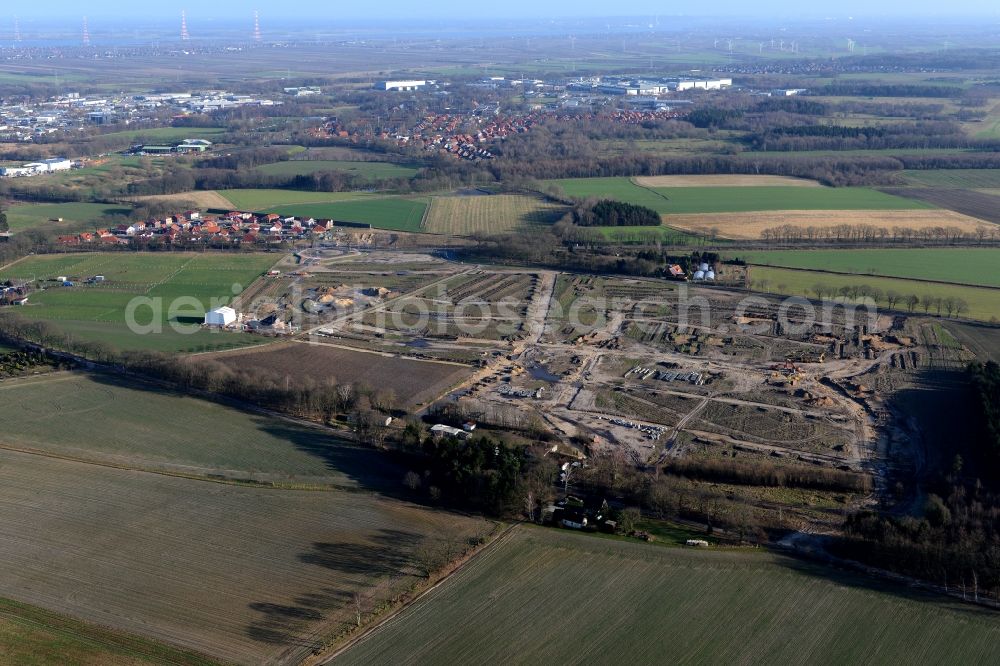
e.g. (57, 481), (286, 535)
(7, 0), (1000, 22)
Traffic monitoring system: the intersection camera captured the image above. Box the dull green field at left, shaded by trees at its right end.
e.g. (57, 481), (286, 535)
(0, 372), (388, 482)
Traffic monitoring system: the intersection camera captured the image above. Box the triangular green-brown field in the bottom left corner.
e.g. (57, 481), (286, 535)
(0, 599), (218, 666)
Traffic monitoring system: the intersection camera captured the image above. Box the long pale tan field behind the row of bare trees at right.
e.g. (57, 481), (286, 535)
(664, 210), (988, 240)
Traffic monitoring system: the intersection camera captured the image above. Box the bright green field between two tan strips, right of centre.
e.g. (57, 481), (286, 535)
(547, 178), (933, 214)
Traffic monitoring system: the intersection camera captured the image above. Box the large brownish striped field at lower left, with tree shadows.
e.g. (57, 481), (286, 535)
(0, 451), (490, 664)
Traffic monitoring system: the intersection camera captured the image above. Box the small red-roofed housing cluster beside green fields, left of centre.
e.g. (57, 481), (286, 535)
(56, 210), (344, 246)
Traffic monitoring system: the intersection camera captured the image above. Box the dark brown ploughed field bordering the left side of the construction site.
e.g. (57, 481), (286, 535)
(212, 343), (472, 406)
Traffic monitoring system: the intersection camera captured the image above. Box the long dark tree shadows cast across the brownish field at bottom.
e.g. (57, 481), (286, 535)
(246, 529), (426, 649)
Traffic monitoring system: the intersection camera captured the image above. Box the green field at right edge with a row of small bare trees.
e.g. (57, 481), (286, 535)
(751, 266), (1000, 321)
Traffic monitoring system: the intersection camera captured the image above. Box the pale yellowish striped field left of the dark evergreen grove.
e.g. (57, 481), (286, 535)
(424, 194), (566, 236)
